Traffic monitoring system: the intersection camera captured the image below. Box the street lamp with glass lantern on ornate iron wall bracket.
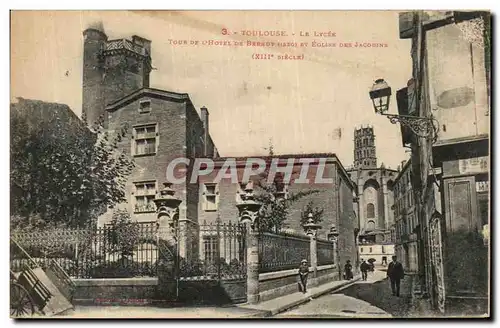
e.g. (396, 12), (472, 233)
(370, 79), (437, 139)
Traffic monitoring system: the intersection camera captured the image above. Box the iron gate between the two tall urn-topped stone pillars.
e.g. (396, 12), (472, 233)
(158, 221), (247, 304)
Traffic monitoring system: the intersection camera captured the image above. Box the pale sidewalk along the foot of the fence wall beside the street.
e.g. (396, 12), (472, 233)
(238, 275), (361, 316)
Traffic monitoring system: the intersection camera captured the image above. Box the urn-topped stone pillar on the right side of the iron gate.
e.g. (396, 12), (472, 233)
(236, 183), (262, 304)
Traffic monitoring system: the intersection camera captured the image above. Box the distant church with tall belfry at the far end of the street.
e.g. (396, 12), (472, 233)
(348, 127), (398, 265)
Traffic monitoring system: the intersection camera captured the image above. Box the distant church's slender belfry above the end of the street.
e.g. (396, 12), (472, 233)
(354, 126), (377, 169)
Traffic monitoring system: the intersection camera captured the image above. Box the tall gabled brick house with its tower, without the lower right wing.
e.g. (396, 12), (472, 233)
(82, 24), (218, 258)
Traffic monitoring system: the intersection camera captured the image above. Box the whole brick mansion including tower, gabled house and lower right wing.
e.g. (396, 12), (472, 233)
(82, 25), (358, 261)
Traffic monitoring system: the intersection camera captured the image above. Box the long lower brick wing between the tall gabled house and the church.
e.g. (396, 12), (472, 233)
(198, 153), (359, 263)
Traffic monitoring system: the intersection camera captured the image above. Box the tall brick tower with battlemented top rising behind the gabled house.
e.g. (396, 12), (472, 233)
(82, 23), (151, 126)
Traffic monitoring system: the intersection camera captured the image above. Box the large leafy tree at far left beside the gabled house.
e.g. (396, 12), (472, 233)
(10, 99), (134, 228)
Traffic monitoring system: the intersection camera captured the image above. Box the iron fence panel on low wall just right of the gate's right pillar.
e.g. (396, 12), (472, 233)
(258, 232), (310, 273)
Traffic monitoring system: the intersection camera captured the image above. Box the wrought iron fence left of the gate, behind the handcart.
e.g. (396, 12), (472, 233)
(10, 223), (158, 278)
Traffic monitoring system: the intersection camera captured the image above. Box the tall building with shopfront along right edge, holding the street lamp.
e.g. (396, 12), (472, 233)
(398, 11), (491, 315)
